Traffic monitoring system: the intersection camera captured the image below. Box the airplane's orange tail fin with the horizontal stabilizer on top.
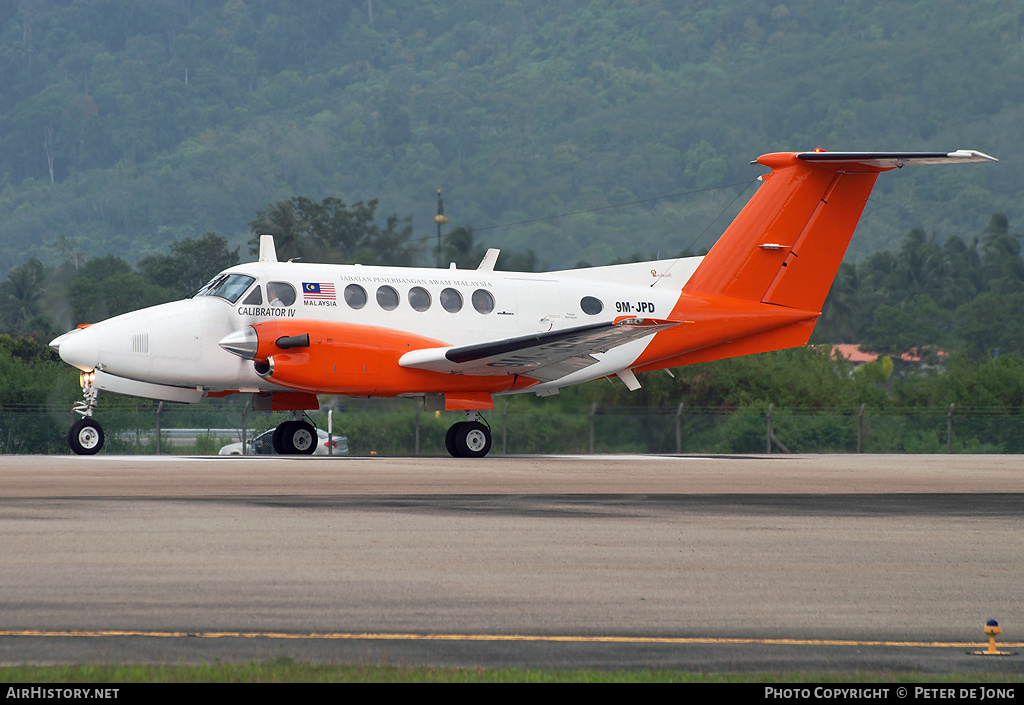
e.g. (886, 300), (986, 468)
(683, 151), (992, 310)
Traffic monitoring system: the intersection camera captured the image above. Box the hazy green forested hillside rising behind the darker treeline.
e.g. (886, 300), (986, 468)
(0, 0), (1024, 273)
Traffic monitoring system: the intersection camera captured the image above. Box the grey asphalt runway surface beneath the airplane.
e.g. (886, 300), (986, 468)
(0, 455), (1024, 674)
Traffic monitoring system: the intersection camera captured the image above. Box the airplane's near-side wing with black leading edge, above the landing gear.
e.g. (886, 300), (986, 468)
(398, 316), (679, 382)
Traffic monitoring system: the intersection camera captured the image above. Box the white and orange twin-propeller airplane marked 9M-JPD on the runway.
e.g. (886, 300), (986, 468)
(50, 150), (997, 458)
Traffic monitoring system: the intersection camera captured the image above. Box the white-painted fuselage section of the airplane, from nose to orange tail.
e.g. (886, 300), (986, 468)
(53, 257), (700, 401)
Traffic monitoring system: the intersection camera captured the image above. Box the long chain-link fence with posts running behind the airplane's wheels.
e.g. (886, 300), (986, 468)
(0, 401), (1024, 457)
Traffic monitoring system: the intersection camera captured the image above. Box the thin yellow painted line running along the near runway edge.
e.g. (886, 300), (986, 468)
(0, 629), (1024, 649)
